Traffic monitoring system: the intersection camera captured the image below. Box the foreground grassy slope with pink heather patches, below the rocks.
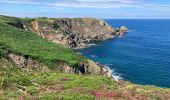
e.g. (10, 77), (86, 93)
(0, 59), (170, 100)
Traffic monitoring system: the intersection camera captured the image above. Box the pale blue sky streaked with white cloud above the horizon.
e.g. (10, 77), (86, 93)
(0, 0), (170, 19)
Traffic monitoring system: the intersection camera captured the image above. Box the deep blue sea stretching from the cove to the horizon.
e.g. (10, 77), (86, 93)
(78, 19), (170, 88)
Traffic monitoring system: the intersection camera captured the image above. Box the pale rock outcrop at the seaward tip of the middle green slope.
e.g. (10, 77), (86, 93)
(56, 60), (112, 77)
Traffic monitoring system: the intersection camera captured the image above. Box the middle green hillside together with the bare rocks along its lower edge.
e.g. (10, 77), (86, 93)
(0, 17), (113, 75)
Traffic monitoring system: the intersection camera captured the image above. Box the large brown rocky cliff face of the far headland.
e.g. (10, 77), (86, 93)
(22, 18), (124, 48)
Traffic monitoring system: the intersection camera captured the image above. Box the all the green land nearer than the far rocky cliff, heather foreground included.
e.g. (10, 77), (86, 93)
(0, 16), (170, 100)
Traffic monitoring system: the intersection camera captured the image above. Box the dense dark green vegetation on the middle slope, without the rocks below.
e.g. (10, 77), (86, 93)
(0, 22), (86, 67)
